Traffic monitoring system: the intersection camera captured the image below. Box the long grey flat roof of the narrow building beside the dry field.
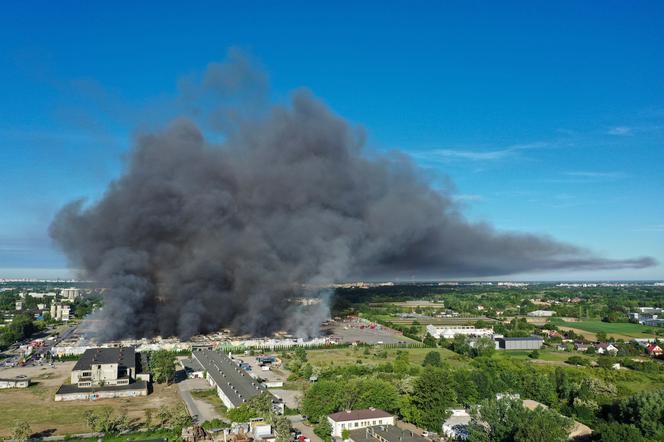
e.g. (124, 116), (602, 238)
(192, 350), (267, 407)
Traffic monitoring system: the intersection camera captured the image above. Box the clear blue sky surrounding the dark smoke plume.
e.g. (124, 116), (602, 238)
(0, 1), (664, 279)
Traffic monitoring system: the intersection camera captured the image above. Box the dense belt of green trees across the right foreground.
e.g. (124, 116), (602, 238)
(302, 351), (664, 440)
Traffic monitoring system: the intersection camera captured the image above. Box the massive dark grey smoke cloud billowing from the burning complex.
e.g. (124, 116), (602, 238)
(51, 55), (653, 338)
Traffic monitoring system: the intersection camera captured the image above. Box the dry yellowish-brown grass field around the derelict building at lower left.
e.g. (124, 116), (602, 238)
(0, 362), (181, 438)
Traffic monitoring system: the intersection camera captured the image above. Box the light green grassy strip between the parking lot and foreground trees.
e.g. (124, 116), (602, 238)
(307, 347), (468, 367)
